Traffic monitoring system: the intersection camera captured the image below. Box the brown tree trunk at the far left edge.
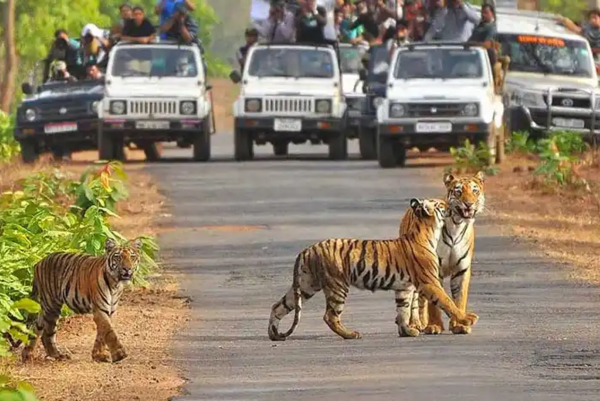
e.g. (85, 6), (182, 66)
(0, 0), (17, 113)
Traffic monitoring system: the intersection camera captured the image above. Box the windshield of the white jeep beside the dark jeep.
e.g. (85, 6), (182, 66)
(111, 46), (198, 78)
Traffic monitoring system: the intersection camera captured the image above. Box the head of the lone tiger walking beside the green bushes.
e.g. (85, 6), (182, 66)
(104, 238), (142, 281)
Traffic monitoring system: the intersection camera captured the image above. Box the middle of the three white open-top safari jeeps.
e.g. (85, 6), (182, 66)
(230, 43), (348, 161)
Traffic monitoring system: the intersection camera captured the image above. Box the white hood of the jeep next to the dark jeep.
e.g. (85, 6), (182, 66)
(106, 78), (200, 98)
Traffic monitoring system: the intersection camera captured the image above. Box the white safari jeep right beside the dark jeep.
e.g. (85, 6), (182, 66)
(98, 42), (214, 161)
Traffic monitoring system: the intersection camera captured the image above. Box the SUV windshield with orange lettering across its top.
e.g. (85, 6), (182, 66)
(498, 34), (594, 78)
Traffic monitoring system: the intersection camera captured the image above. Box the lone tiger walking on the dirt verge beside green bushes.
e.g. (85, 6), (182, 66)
(22, 238), (142, 362)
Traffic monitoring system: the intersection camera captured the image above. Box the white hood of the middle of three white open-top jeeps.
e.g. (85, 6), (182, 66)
(240, 78), (339, 97)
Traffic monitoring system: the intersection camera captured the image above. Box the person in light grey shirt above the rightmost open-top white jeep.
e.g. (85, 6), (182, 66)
(423, 0), (481, 42)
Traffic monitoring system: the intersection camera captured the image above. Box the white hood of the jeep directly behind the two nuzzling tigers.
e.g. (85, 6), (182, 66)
(387, 80), (489, 101)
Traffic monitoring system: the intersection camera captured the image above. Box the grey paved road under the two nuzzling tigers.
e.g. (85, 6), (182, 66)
(148, 135), (600, 401)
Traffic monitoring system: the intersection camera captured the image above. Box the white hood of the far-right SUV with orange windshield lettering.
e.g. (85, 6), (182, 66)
(505, 72), (598, 91)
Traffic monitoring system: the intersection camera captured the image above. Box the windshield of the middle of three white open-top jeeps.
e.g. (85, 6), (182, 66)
(248, 47), (335, 79)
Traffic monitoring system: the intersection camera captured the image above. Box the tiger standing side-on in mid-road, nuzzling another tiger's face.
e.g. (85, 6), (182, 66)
(268, 199), (478, 341)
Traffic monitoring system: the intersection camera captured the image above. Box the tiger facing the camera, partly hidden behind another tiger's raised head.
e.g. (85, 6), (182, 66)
(400, 171), (485, 334)
